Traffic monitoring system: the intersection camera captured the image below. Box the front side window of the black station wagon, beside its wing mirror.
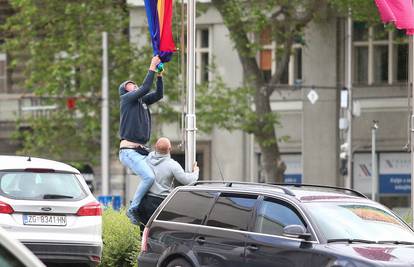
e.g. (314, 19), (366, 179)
(254, 198), (306, 235)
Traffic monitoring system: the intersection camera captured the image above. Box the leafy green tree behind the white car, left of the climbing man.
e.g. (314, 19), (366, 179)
(1, 0), (178, 163)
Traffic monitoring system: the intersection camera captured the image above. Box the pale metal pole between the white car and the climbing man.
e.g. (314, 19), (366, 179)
(101, 32), (109, 195)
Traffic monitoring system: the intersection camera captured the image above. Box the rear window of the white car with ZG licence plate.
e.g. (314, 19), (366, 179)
(0, 172), (86, 200)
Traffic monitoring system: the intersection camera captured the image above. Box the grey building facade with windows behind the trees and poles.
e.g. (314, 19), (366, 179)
(0, 0), (411, 213)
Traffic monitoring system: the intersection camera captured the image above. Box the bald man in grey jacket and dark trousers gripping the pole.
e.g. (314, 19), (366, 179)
(138, 137), (199, 230)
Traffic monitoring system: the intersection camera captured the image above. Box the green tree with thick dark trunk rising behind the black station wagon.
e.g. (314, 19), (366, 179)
(197, 0), (378, 182)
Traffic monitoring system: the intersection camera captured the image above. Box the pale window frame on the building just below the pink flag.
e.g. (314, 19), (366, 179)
(352, 24), (408, 85)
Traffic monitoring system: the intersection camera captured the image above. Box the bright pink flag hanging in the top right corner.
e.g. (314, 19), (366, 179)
(375, 0), (414, 35)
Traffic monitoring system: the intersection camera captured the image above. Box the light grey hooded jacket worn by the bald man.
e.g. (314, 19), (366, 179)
(147, 151), (199, 196)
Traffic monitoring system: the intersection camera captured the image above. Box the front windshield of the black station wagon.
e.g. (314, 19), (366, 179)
(305, 202), (414, 243)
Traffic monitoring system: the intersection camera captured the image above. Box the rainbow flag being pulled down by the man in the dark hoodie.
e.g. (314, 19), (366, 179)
(145, 0), (175, 62)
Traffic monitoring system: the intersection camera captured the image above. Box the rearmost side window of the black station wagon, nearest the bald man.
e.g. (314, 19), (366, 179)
(157, 191), (215, 224)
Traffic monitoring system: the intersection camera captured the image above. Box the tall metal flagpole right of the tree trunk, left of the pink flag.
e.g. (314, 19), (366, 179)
(344, 9), (353, 188)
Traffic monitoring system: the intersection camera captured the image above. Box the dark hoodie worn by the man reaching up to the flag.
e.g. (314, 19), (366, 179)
(119, 71), (164, 144)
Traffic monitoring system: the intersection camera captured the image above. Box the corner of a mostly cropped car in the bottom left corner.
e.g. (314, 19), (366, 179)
(0, 227), (45, 267)
